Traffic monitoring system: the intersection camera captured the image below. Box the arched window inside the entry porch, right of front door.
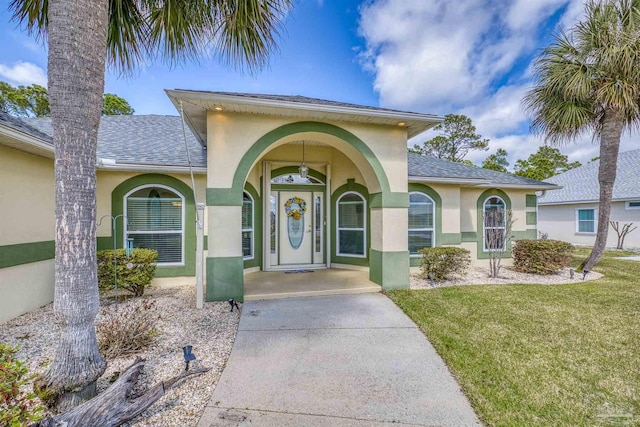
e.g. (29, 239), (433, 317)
(336, 192), (367, 258)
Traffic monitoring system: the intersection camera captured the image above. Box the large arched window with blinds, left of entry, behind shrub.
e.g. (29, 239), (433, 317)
(124, 185), (184, 265)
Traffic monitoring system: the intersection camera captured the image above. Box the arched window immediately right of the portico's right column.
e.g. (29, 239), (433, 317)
(409, 192), (436, 255)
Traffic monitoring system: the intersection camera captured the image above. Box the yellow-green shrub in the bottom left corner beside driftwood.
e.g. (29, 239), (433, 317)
(0, 344), (44, 426)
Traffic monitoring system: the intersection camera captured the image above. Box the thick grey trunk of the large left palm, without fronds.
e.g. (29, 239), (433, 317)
(37, 0), (108, 411)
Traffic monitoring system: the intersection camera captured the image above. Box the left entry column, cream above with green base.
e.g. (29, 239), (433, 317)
(206, 202), (244, 301)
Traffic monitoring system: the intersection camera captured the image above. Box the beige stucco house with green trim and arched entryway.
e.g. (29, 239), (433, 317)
(0, 90), (555, 321)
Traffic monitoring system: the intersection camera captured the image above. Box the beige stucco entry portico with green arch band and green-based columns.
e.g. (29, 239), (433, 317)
(206, 111), (409, 301)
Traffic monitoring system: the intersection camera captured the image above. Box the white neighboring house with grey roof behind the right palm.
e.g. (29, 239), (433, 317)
(538, 150), (640, 248)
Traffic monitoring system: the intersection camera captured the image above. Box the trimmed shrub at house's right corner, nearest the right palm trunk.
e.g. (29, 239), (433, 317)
(512, 240), (573, 274)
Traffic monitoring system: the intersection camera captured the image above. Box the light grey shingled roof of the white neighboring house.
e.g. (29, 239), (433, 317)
(538, 150), (640, 205)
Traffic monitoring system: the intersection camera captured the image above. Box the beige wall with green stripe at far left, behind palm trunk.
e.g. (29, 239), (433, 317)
(0, 145), (55, 323)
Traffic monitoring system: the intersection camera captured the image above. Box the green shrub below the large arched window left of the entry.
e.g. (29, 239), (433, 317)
(97, 248), (158, 297)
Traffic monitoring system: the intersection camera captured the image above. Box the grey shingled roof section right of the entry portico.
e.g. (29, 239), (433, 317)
(408, 153), (555, 187)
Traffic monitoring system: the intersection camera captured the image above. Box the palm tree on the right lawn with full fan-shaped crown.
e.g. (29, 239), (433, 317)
(524, 0), (640, 271)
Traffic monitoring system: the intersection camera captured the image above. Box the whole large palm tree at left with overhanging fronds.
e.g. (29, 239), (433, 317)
(10, 0), (291, 410)
